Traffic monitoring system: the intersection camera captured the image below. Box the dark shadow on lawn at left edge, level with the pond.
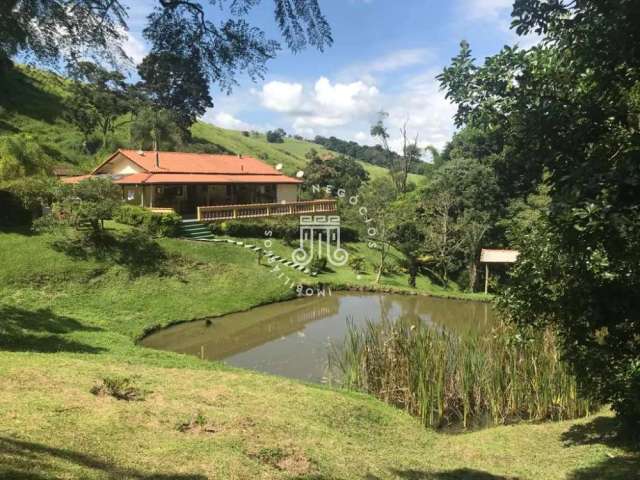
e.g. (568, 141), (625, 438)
(0, 305), (103, 353)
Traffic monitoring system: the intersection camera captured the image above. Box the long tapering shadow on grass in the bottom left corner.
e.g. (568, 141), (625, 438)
(0, 437), (207, 480)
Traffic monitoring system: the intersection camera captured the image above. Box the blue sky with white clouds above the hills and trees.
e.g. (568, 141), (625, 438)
(119, 0), (536, 150)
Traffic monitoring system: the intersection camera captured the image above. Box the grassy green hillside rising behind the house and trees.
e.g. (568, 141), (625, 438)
(0, 66), (422, 184)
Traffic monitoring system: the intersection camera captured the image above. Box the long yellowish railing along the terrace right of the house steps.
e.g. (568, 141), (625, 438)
(198, 200), (337, 222)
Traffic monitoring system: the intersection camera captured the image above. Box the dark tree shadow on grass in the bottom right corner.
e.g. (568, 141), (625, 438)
(562, 417), (640, 480)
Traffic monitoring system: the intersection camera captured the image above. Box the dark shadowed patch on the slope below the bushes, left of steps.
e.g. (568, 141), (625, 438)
(51, 230), (169, 277)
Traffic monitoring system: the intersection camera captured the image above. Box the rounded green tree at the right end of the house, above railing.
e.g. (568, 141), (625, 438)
(303, 148), (369, 195)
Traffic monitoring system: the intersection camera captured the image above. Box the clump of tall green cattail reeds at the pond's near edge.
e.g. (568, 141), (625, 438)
(329, 320), (594, 428)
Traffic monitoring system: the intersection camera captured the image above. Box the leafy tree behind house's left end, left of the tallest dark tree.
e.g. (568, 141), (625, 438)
(67, 62), (132, 148)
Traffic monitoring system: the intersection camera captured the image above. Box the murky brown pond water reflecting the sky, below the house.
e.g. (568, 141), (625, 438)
(141, 292), (495, 382)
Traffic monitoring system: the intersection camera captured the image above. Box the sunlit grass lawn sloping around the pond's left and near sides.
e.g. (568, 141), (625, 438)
(0, 227), (640, 480)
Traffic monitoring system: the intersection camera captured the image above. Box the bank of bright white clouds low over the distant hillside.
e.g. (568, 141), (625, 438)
(250, 69), (455, 151)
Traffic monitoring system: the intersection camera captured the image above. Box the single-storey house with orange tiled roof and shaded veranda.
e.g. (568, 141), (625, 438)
(63, 149), (305, 218)
